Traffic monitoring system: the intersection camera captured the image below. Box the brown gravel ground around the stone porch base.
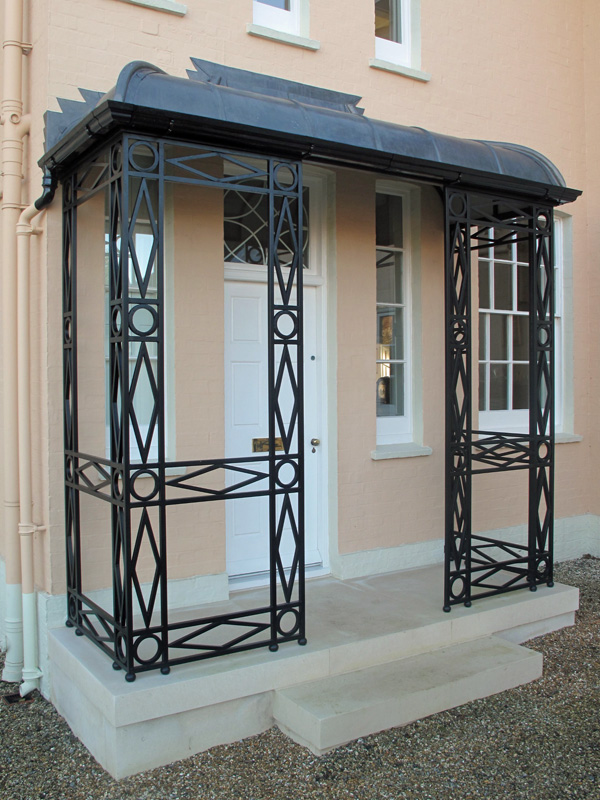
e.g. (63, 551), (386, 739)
(0, 557), (600, 800)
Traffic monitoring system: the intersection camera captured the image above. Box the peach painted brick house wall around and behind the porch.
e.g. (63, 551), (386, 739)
(2, 0), (600, 591)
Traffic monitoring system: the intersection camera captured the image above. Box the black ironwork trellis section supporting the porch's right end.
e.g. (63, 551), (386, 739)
(444, 188), (554, 611)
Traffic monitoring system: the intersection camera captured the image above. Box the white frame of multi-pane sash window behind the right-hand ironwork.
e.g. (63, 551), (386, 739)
(474, 216), (569, 433)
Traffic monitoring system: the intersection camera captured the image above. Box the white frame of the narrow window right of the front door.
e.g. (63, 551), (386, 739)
(375, 181), (414, 447)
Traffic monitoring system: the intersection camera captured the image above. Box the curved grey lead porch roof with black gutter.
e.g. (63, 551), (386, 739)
(40, 59), (580, 203)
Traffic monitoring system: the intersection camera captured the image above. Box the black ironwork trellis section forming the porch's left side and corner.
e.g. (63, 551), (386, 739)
(63, 135), (306, 680)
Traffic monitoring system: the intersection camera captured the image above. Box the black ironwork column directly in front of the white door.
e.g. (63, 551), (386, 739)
(268, 161), (306, 650)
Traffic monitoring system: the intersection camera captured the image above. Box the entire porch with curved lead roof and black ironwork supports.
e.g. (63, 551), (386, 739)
(47, 59), (580, 680)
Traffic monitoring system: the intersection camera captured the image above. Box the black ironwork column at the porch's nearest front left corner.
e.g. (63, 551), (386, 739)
(116, 136), (169, 680)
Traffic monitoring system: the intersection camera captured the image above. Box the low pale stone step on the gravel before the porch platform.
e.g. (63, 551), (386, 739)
(274, 636), (542, 755)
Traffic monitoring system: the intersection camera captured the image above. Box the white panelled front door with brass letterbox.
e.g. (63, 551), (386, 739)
(225, 280), (327, 580)
